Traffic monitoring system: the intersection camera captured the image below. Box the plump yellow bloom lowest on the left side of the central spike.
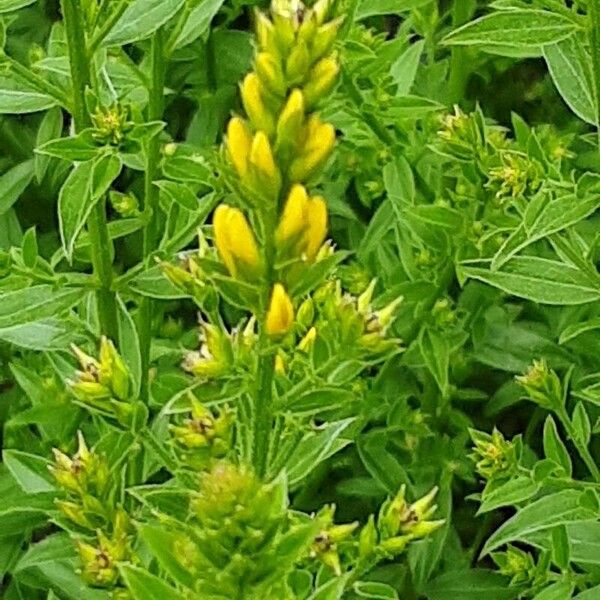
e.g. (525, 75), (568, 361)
(213, 204), (260, 277)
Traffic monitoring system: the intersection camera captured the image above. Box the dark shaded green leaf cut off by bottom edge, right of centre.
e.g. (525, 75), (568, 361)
(424, 569), (519, 600)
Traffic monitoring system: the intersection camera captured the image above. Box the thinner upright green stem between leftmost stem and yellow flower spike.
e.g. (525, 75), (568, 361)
(138, 29), (166, 399)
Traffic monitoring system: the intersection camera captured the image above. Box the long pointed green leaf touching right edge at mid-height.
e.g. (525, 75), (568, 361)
(457, 256), (600, 305)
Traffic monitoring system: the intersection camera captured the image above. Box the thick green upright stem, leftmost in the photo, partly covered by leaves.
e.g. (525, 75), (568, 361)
(61, 0), (118, 339)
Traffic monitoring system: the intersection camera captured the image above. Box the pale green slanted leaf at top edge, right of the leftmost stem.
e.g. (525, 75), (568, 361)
(104, 0), (185, 46)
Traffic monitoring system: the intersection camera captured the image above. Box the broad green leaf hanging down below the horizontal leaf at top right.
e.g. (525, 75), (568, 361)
(544, 35), (598, 126)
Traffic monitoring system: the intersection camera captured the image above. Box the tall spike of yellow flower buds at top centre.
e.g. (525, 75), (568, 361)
(213, 0), (342, 337)
